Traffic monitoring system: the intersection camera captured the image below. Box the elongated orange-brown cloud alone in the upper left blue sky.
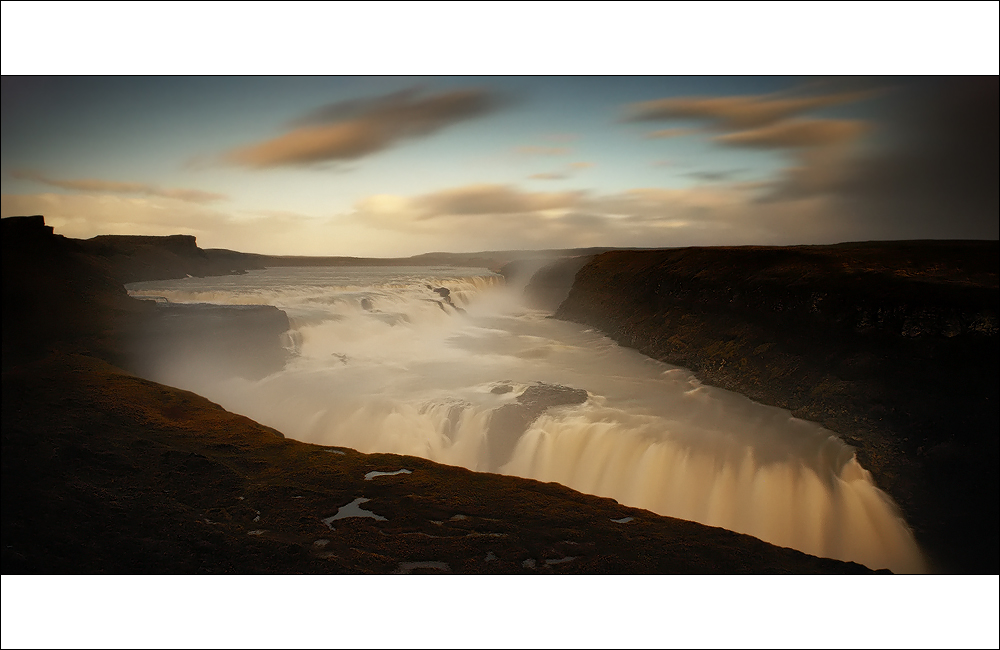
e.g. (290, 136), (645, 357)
(223, 89), (502, 169)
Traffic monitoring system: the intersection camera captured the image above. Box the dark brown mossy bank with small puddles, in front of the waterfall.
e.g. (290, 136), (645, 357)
(0, 217), (869, 574)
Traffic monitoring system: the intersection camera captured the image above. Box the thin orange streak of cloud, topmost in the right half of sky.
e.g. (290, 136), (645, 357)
(625, 90), (873, 129)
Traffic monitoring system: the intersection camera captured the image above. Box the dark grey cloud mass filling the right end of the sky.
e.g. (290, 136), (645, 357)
(767, 77), (1000, 239)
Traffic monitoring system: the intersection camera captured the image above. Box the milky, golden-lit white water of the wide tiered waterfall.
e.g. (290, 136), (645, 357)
(129, 267), (924, 573)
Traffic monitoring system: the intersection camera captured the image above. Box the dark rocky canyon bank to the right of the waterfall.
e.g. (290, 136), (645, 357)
(524, 241), (1000, 574)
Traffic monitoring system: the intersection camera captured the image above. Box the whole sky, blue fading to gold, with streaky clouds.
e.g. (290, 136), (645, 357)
(0, 3), (998, 257)
